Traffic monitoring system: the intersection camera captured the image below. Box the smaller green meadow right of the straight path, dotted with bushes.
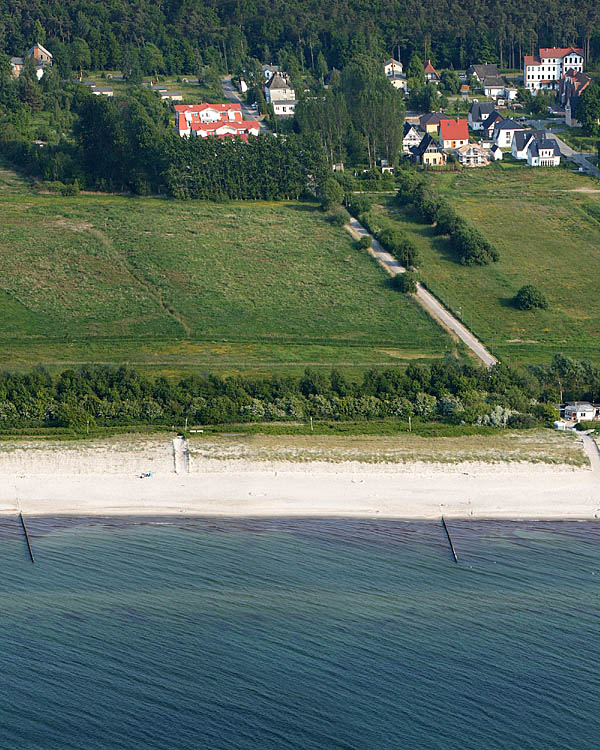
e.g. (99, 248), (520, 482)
(386, 163), (600, 363)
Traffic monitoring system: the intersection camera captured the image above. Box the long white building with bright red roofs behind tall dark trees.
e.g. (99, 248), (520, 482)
(173, 103), (260, 140)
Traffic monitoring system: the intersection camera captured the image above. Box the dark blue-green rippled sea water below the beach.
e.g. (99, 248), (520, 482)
(0, 519), (600, 750)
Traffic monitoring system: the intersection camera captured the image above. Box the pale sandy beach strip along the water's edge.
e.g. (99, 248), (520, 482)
(0, 437), (600, 519)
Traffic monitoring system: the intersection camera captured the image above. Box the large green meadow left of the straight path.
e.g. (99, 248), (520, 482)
(0, 164), (452, 374)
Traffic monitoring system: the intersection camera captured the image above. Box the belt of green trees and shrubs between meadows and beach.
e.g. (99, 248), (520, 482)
(0, 355), (600, 430)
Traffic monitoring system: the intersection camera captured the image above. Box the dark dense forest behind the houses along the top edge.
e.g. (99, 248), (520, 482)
(0, 0), (600, 79)
